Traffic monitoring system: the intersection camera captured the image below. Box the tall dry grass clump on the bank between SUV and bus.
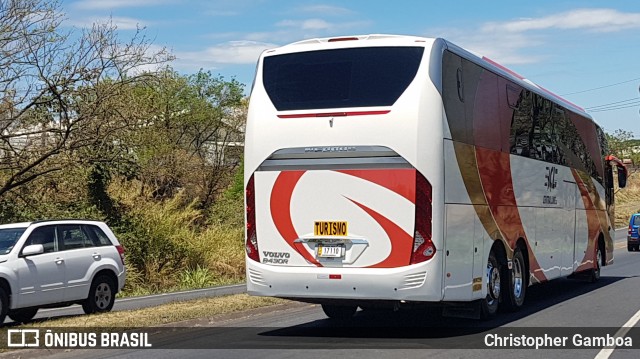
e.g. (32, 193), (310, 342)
(110, 183), (245, 295)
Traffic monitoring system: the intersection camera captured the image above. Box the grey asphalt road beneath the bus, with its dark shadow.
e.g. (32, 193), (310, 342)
(5, 230), (640, 359)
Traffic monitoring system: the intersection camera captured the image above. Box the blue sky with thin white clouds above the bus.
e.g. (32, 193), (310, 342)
(61, 0), (640, 138)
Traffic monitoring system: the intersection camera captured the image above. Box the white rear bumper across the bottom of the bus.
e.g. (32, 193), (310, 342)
(247, 260), (442, 302)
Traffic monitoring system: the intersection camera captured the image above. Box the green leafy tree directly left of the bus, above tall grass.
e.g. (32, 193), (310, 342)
(106, 68), (247, 208)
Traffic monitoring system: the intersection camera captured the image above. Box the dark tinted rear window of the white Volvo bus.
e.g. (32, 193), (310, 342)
(262, 47), (424, 111)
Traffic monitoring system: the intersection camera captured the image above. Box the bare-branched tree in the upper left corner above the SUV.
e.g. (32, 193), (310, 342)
(0, 0), (170, 197)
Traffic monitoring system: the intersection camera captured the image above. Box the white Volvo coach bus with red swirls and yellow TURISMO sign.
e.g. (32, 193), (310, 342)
(244, 35), (626, 319)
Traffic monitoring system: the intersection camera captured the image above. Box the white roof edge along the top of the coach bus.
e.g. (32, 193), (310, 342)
(266, 34), (593, 121)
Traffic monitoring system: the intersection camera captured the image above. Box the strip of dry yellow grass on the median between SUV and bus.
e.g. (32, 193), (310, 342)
(24, 294), (288, 329)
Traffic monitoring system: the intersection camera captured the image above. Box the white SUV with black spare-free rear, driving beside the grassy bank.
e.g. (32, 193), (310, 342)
(0, 220), (126, 324)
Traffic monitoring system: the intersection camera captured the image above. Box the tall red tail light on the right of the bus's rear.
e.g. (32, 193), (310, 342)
(411, 171), (436, 264)
